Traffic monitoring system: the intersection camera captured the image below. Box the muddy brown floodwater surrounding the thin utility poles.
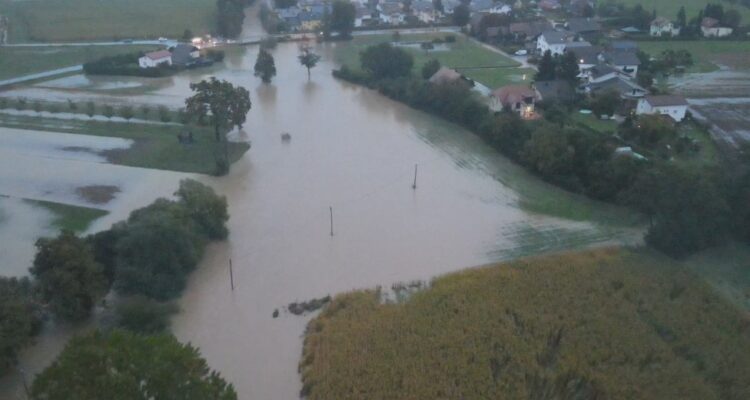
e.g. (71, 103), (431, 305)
(0, 40), (640, 399)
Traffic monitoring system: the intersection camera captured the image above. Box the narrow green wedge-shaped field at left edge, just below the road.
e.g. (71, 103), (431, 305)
(0, 45), (157, 80)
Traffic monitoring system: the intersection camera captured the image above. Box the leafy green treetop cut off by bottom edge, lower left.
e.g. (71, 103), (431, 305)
(31, 330), (237, 400)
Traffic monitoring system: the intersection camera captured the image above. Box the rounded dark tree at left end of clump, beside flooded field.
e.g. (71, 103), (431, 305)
(30, 231), (107, 321)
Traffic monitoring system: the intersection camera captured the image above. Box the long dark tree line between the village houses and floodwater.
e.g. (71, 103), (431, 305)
(334, 43), (750, 257)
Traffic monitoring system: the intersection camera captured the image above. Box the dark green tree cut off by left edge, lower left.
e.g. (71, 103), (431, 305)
(0, 277), (41, 376)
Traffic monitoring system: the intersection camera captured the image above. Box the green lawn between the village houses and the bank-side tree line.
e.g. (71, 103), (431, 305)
(335, 33), (534, 89)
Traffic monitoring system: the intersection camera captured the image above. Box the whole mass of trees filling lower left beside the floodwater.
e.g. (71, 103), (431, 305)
(0, 179), (236, 399)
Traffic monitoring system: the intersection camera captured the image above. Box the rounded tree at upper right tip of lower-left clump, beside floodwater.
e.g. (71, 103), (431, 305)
(174, 179), (229, 240)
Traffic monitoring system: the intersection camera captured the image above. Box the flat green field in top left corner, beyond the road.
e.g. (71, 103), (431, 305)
(0, 0), (216, 43)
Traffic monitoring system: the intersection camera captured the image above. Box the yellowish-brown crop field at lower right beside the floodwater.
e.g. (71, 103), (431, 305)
(300, 249), (750, 400)
